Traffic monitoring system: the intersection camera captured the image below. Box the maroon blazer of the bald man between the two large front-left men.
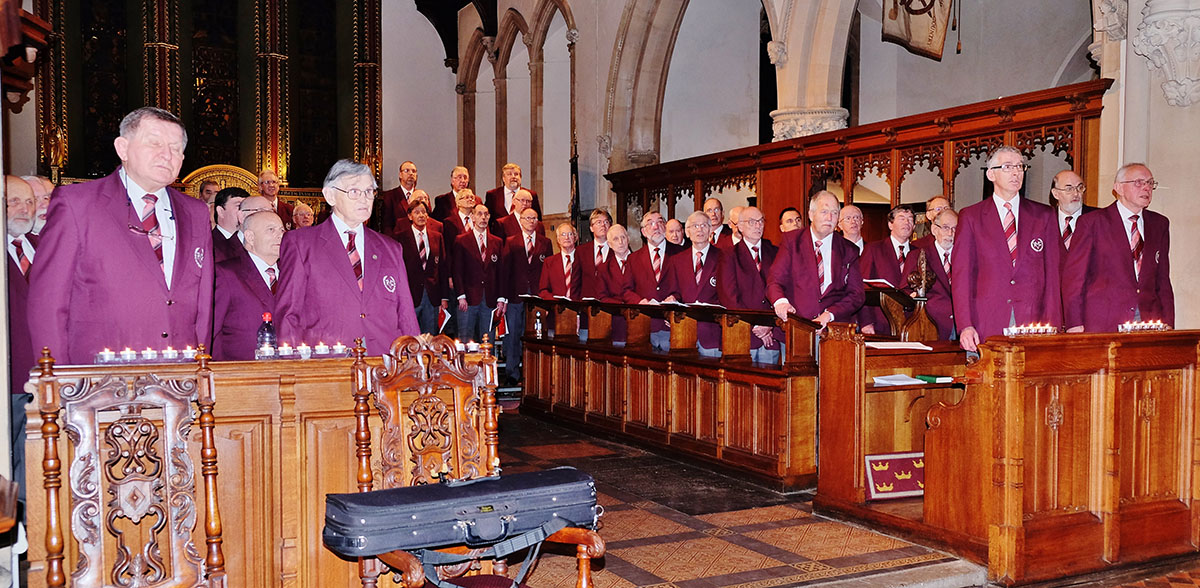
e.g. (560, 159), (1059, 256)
(212, 248), (278, 361)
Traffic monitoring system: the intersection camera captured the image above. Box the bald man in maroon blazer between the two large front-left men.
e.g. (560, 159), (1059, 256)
(212, 210), (283, 361)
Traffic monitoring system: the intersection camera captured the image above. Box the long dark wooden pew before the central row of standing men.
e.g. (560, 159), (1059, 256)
(521, 299), (817, 488)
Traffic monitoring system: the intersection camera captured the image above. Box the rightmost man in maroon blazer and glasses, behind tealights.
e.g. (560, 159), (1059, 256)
(1062, 163), (1175, 332)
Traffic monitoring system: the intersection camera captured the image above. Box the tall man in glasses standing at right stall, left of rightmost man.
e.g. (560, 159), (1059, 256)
(950, 146), (1062, 352)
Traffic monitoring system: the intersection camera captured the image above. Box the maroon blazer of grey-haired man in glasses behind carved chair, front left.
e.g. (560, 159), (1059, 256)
(275, 218), (421, 355)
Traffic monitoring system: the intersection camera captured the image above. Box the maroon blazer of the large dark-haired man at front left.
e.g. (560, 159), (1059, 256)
(28, 172), (214, 365)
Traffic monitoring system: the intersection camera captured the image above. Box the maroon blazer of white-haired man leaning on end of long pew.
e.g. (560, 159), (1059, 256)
(767, 229), (864, 322)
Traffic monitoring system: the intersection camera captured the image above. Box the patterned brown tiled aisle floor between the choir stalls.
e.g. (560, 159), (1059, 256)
(500, 410), (954, 588)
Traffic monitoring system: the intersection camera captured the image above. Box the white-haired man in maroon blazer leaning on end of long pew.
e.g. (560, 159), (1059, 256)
(767, 191), (863, 326)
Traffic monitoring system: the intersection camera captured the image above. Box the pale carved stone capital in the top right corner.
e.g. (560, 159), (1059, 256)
(1133, 0), (1200, 107)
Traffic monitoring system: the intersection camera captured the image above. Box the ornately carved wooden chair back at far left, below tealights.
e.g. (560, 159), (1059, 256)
(37, 348), (226, 588)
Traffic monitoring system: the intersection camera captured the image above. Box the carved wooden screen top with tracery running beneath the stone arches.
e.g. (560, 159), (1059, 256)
(605, 78), (1112, 242)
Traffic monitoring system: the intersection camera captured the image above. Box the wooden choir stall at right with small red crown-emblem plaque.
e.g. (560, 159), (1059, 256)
(814, 324), (1200, 584)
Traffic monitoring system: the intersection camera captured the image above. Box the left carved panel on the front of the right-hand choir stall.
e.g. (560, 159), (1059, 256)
(1024, 376), (1103, 518)
